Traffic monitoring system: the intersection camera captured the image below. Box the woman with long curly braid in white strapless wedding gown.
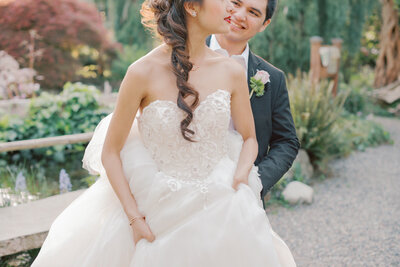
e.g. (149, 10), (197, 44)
(32, 0), (296, 267)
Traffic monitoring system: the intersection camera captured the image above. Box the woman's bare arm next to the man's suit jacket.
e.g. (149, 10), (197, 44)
(231, 61), (258, 189)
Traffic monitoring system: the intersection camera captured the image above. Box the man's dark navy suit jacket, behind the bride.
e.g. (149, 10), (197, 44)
(206, 37), (300, 207)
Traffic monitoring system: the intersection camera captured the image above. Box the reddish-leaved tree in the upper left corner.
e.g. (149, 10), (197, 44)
(0, 0), (116, 89)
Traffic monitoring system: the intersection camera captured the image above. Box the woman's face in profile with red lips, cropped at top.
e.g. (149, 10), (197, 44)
(197, 0), (233, 34)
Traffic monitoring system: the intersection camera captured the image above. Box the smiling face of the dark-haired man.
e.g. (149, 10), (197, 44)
(224, 0), (270, 42)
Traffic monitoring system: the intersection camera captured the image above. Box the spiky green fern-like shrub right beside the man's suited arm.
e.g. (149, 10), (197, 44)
(288, 73), (348, 165)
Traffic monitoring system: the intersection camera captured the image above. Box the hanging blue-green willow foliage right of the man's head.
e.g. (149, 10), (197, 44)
(251, 0), (377, 79)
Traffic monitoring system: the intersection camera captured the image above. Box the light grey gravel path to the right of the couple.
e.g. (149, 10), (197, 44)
(267, 118), (400, 267)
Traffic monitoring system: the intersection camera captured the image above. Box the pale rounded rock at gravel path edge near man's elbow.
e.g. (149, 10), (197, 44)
(282, 181), (314, 204)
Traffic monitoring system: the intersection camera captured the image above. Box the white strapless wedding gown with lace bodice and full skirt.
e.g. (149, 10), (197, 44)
(32, 89), (296, 267)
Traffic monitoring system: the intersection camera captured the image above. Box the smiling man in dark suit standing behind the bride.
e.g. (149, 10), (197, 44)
(207, 0), (300, 208)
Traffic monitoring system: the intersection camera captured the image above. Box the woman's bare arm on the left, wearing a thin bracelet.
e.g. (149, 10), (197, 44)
(101, 63), (154, 242)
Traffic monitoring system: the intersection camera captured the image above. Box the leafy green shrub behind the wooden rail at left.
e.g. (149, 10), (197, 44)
(0, 83), (108, 164)
